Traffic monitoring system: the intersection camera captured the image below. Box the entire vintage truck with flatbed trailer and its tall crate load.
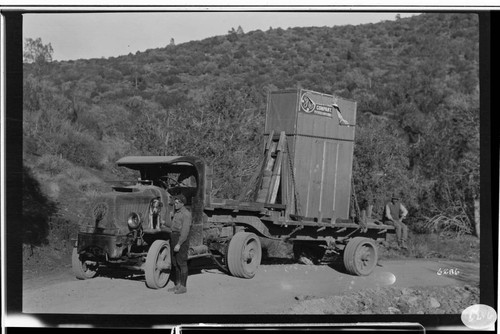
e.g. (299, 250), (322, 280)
(72, 89), (394, 289)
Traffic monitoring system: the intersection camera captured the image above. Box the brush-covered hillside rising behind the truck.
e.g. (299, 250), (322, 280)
(23, 13), (479, 268)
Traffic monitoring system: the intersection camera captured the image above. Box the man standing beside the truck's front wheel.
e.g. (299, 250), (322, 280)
(168, 194), (192, 294)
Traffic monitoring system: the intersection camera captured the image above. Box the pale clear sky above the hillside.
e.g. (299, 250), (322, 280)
(23, 11), (418, 61)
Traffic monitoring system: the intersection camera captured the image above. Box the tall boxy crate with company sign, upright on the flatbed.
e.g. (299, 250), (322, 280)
(265, 89), (356, 221)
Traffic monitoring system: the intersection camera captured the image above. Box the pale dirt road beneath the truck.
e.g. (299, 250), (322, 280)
(23, 260), (479, 314)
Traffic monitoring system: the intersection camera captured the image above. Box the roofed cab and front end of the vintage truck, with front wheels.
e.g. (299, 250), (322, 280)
(72, 156), (207, 288)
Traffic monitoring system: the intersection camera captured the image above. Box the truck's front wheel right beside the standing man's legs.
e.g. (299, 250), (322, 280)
(144, 240), (171, 289)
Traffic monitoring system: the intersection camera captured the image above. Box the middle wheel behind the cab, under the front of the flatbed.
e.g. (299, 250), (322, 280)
(227, 232), (262, 278)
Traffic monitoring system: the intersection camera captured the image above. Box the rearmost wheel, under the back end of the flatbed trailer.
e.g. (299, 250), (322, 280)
(344, 237), (378, 276)
